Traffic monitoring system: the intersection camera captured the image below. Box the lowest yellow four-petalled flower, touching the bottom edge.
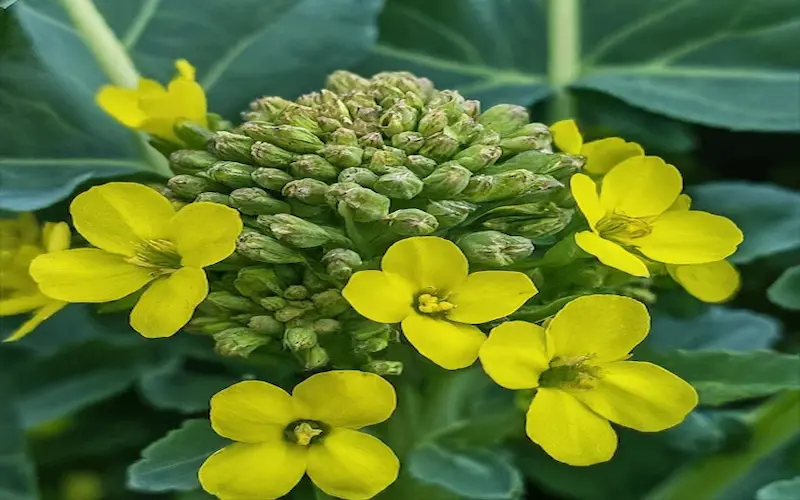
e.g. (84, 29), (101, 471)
(199, 370), (400, 500)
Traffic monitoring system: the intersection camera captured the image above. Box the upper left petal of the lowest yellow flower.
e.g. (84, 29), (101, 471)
(211, 380), (311, 443)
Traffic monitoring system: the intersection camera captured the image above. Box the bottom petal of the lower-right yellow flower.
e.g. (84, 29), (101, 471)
(525, 388), (617, 465)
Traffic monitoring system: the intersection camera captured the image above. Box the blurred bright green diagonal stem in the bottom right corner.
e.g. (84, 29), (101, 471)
(645, 391), (800, 500)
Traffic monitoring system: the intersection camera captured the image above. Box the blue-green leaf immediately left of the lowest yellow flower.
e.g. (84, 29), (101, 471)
(128, 419), (230, 492)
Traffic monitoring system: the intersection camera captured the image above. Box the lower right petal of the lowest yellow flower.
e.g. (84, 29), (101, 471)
(308, 429), (400, 500)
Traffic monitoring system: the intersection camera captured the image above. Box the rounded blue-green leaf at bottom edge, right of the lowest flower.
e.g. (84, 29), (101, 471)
(407, 444), (523, 500)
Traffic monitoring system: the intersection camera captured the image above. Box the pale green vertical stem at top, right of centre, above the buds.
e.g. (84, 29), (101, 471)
(547, 0), (581, 123)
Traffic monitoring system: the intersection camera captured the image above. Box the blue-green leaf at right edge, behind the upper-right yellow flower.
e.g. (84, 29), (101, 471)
(690, 182), (800, 264)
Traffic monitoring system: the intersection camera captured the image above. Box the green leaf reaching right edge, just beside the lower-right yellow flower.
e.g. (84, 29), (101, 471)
(637, 350), (800, 406)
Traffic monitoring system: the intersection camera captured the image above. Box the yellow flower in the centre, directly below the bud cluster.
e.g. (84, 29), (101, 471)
(342, 236), (537, 370)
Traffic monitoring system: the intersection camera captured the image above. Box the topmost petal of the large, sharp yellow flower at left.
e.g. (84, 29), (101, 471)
(70, 182), (175, 255)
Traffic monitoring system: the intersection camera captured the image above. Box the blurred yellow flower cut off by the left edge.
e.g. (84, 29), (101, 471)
(0, 213), (70, 342)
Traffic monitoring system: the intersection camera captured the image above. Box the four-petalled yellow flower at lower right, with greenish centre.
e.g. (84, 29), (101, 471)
(480, 295), (697, 465)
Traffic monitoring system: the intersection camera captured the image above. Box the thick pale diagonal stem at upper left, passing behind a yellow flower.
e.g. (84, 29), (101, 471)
(60, 0), (172, 177)
